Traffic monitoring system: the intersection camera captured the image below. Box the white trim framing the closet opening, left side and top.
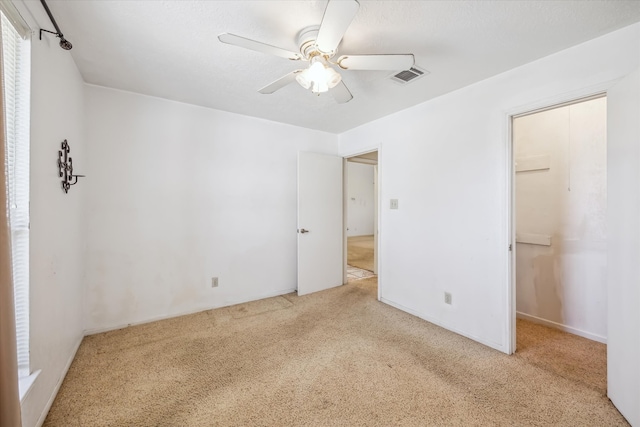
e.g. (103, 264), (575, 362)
(503, 83), (620, 354)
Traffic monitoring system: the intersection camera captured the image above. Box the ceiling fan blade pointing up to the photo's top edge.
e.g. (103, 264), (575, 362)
(316, 0), (360, 53)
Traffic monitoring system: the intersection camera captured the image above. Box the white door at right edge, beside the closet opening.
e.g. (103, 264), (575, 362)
(607, 70), (640, 426)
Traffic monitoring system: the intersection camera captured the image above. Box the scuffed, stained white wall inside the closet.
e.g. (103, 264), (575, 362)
(513, 98), (607, 342)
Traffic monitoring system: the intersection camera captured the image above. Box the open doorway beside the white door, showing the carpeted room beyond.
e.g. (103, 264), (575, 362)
(344, 150), (378, 282)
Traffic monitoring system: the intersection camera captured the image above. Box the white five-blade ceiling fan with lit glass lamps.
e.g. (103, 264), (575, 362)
(218, 0), (414, 104)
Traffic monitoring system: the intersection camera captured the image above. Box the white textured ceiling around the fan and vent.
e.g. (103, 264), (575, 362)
(18, 0), (640, 133)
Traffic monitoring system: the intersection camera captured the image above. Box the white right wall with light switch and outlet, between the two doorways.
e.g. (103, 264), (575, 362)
(340, 24), (640, 353)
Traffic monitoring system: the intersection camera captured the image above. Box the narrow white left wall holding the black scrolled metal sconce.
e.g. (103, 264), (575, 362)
(22, 28), (88, 427)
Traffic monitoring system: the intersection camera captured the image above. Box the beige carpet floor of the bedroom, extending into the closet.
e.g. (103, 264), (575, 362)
(45, 278), (627, 427)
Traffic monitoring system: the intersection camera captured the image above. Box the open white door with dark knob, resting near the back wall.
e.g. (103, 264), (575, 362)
(298, 152), (343, 295)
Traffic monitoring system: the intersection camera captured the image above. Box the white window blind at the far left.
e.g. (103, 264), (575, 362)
(0, 13), (31, 376)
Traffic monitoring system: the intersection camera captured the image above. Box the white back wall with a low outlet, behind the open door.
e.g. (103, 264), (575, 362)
(85, 86), (337, 332)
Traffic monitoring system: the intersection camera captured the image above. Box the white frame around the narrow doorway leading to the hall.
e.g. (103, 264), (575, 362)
(341, 144), (382, 301)
